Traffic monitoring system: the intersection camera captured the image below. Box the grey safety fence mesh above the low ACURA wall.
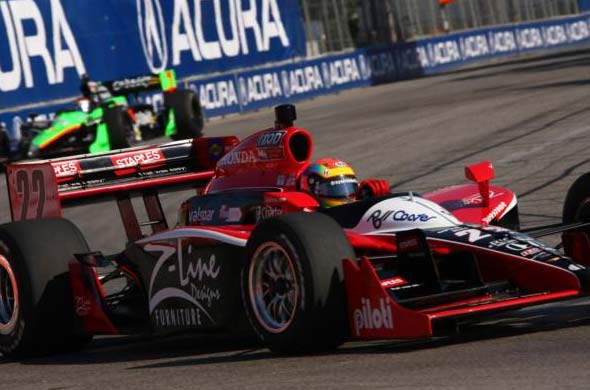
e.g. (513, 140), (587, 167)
(300, 0), (580, 56)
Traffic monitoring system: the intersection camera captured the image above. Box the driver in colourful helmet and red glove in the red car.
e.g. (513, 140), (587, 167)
(299, 158), (389, 207)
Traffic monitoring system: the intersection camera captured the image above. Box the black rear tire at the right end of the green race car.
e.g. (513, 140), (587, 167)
(164, 89), (204, 140)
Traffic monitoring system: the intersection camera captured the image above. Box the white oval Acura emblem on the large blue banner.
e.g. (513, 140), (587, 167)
(137, 0), (168, 73)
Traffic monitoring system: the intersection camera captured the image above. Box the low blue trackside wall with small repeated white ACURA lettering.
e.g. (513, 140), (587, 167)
(0, 14), (590, 147)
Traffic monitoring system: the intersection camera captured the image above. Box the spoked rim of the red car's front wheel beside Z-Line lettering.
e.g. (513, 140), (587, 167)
(248, 242), (299, 333)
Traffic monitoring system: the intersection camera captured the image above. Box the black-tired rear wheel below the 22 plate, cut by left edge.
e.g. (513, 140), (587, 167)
(0, 219), (92, 358)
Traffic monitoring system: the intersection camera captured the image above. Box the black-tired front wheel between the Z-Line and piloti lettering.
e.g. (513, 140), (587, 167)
(241, 213), (355, 354)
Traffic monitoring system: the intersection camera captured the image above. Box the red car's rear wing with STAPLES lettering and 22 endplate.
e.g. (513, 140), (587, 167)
(6, 136), (239, 221)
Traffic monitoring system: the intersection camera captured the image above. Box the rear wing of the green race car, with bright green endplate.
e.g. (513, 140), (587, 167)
(99, 69), (177, 96)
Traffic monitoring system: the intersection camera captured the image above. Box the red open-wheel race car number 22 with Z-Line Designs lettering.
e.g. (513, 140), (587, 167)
(0, 106), (590, 357)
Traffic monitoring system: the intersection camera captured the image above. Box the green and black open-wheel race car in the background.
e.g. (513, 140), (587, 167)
(16, 70), (203, 160)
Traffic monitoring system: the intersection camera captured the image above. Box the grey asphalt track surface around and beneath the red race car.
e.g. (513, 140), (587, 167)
(0, 50), (590, 390)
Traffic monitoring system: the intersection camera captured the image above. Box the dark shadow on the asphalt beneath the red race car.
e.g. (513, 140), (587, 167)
(5, 299), (590, 370)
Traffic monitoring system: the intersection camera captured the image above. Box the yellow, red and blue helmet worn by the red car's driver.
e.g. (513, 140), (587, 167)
(299, 158), (359, 207)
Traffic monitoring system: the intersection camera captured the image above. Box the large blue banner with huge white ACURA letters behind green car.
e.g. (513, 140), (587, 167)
(0, 0), (305, 110)
